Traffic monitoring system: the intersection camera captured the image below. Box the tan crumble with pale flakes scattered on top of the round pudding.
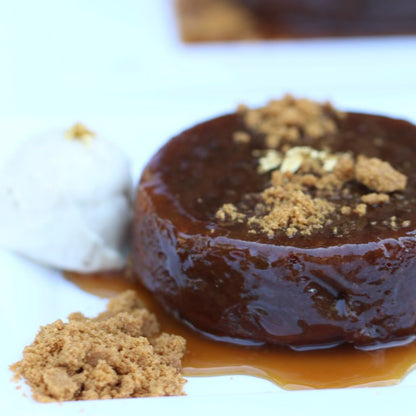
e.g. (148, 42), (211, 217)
(216, 95), (407, 237)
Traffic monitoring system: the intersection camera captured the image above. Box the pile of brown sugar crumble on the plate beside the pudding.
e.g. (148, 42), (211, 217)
(10, 290), (185, 402)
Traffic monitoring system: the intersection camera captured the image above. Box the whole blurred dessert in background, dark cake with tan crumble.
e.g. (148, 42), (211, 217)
(176, 0), (416, 42)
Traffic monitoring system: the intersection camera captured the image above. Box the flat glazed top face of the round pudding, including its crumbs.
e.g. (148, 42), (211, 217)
(149, 96), (416, 247)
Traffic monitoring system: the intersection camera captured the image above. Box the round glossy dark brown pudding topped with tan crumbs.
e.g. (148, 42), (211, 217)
(133, 95), (416, 349)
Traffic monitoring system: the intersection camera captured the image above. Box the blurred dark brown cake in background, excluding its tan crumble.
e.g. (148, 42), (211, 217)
(239, 0), (416, 36)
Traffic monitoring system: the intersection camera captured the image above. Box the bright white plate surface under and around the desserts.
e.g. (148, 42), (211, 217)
(0, 0), (416, 416)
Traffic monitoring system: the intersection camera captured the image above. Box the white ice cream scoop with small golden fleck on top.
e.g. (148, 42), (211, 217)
(0, 124), (132, 272)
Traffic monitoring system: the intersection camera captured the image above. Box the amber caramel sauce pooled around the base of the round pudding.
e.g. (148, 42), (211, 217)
(65, 273), (416, 390)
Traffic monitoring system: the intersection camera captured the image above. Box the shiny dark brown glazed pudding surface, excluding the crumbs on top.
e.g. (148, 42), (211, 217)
(133, 113), (416, 348)
